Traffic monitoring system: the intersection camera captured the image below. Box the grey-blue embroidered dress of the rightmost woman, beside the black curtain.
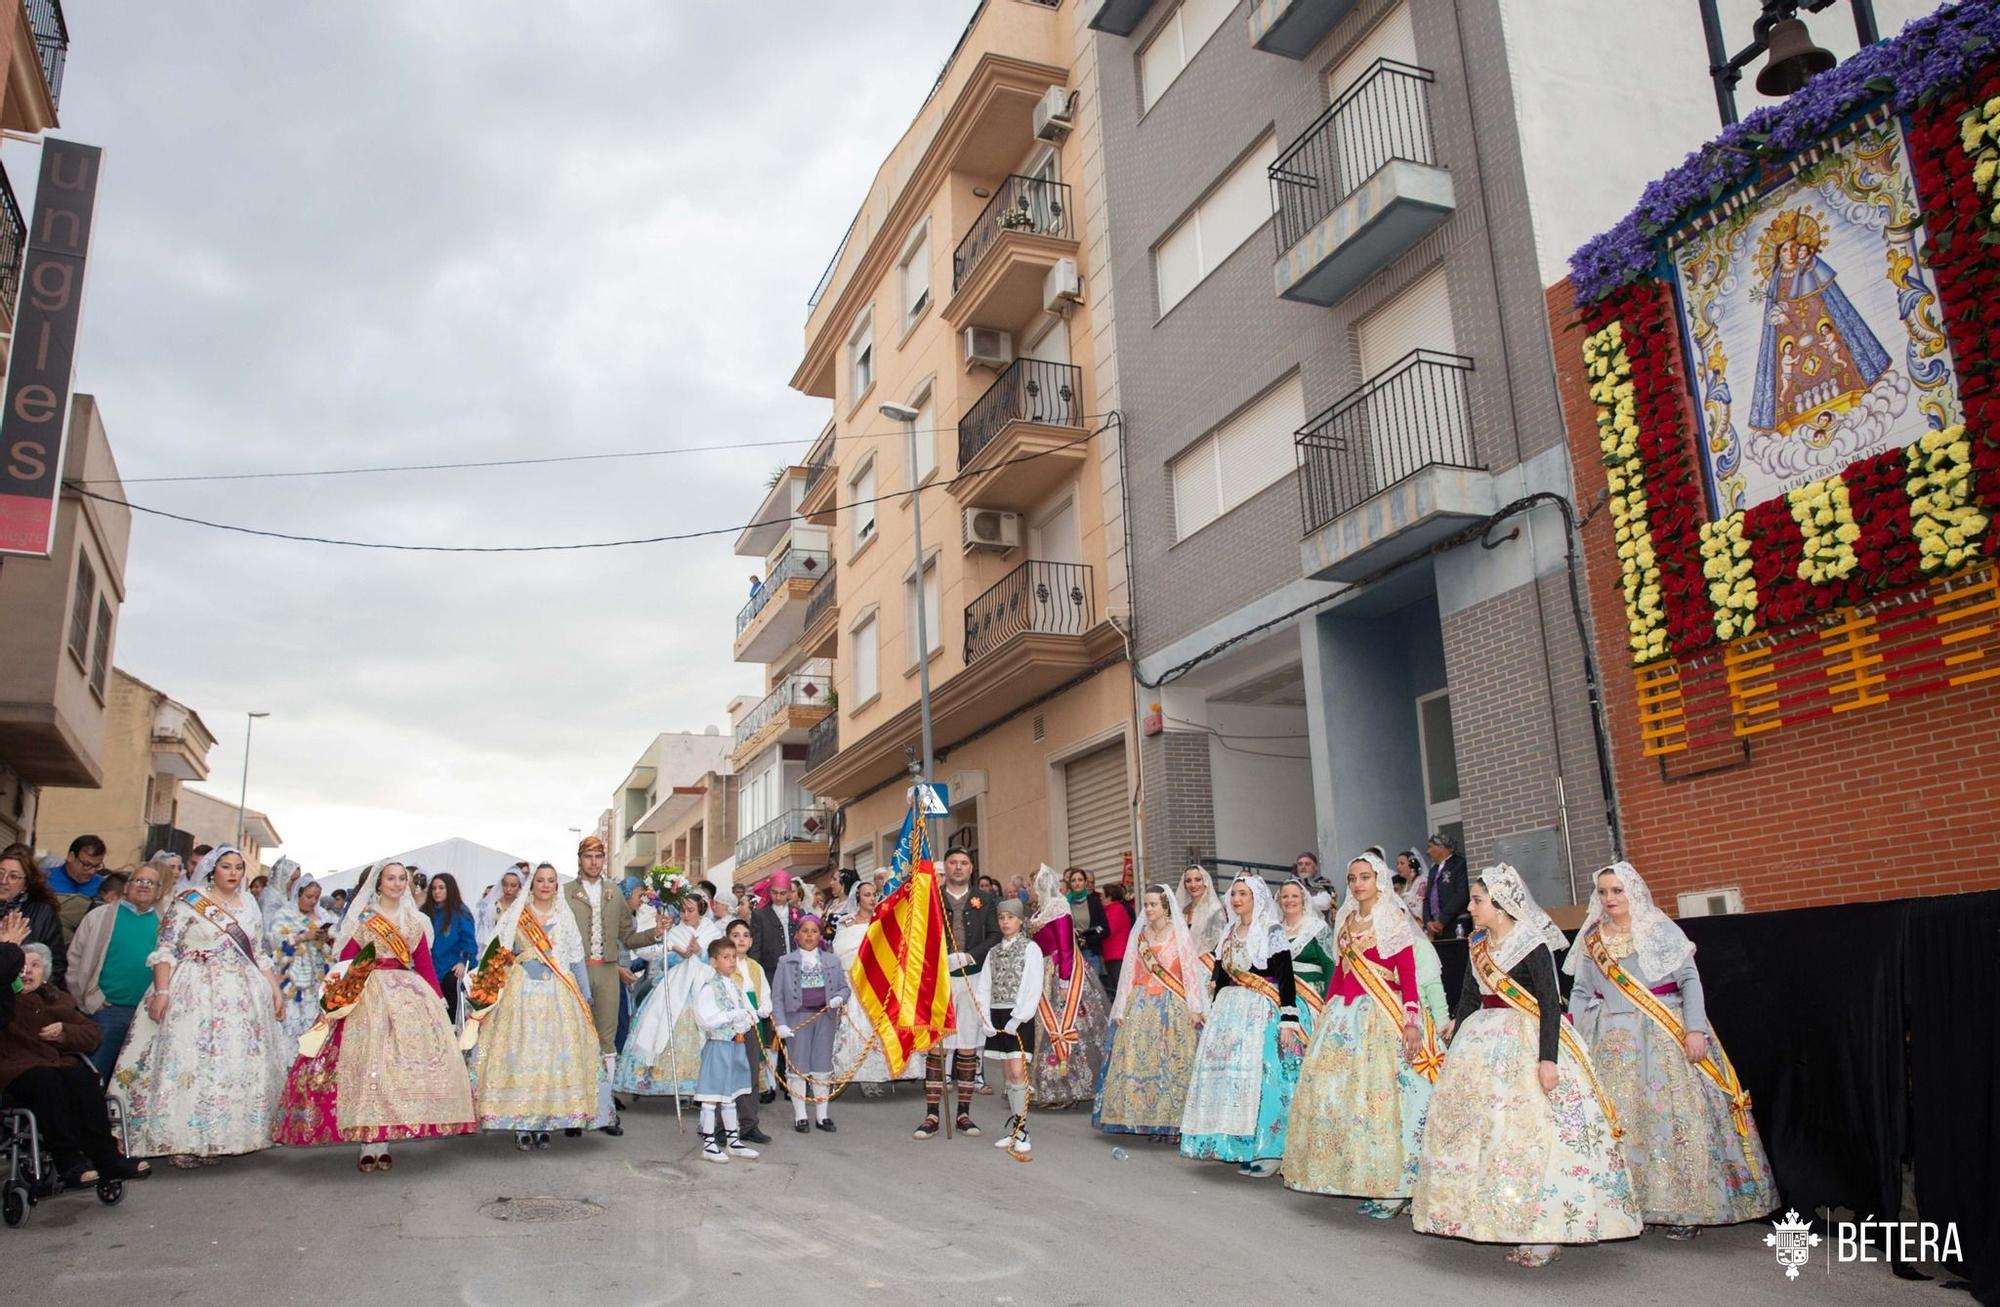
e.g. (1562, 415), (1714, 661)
(1570, 927), (1778, 1225)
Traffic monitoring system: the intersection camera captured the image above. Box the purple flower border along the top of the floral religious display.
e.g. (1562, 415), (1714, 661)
(1570, 0), (2000, 306)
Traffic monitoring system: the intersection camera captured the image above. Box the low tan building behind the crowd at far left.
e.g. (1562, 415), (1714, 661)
(34, 671), (213, 867)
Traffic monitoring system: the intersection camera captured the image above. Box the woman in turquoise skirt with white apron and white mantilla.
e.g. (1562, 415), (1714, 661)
(1180, 873), (1306, 1177)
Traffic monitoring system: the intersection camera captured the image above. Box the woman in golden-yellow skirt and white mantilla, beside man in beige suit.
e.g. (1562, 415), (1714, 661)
(466, 863), (614, 1153)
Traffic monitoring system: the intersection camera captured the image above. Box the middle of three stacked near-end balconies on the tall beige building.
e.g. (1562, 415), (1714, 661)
(952, 358), (1090, 512)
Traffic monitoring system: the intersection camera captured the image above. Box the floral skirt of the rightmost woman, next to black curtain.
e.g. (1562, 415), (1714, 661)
(1578, 1011), (1778, 1225)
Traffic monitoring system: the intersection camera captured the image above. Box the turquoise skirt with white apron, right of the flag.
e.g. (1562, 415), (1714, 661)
(1180, 985), (1298, 1163)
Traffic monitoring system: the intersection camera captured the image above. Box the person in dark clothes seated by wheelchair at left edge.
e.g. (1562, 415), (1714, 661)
(0, 943), (152, 1185)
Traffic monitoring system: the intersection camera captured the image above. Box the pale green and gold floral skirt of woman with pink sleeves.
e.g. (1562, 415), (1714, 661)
(1282, 997), (1430, 1199)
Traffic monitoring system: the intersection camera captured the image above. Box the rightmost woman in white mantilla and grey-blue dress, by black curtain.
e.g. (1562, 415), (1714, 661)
(1564, 861), (1778, 1239)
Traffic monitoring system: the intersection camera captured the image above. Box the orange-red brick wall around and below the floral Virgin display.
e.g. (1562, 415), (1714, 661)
(1548, 280), (2000, 911)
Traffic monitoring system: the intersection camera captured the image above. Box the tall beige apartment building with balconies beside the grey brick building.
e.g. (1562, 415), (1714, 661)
(772, 0), (1136, 881)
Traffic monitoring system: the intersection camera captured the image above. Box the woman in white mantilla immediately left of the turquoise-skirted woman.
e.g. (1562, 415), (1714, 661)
(1090, 885), (1208, 1143)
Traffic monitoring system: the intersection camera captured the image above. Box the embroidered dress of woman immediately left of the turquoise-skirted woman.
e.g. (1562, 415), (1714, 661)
(1090, 931), (1208, 1135)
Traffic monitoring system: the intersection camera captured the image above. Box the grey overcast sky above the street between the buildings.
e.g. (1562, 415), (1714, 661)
(50, 0), (974, 869)
